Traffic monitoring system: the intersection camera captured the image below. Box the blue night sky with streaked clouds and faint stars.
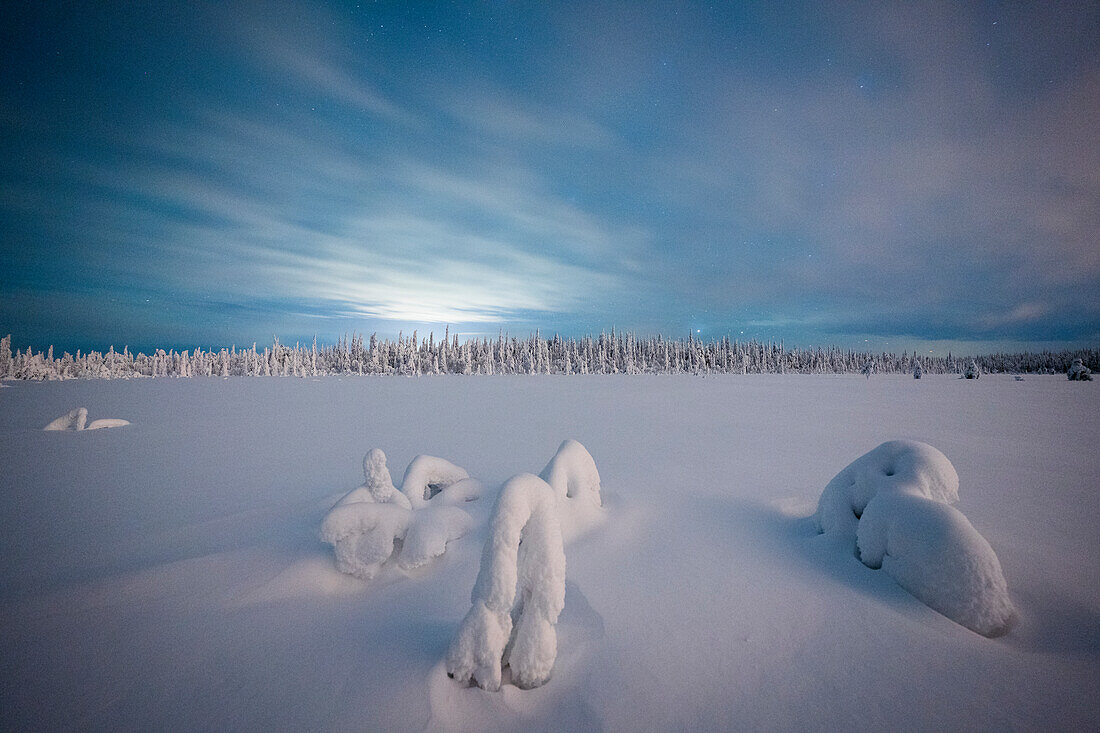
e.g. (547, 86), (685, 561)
(0, 1), (1100, 352)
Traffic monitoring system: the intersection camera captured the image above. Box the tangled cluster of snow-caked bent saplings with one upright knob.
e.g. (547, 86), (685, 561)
(321, 448), (481, 580)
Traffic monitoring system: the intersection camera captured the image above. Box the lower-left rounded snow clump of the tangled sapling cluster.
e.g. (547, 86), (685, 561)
(321, 502), (413, 580)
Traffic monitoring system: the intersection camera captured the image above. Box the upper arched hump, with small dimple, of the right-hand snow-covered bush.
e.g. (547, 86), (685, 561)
(814, 440), (959, 539)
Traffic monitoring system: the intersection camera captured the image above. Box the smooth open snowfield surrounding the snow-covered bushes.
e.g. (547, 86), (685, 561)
(0, 375), (1100, 731)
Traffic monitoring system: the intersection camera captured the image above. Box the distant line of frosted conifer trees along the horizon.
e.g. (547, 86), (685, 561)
(0, 331), (1100, 380)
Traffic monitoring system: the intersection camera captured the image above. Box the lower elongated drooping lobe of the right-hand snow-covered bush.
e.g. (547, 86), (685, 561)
(857, 493), (1015, 637)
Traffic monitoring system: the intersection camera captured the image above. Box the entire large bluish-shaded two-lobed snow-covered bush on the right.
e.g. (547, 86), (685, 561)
(814, 440), (1015, 636)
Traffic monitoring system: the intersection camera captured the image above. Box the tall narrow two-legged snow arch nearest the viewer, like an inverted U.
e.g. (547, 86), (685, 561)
(447, 473), (565, 690)
